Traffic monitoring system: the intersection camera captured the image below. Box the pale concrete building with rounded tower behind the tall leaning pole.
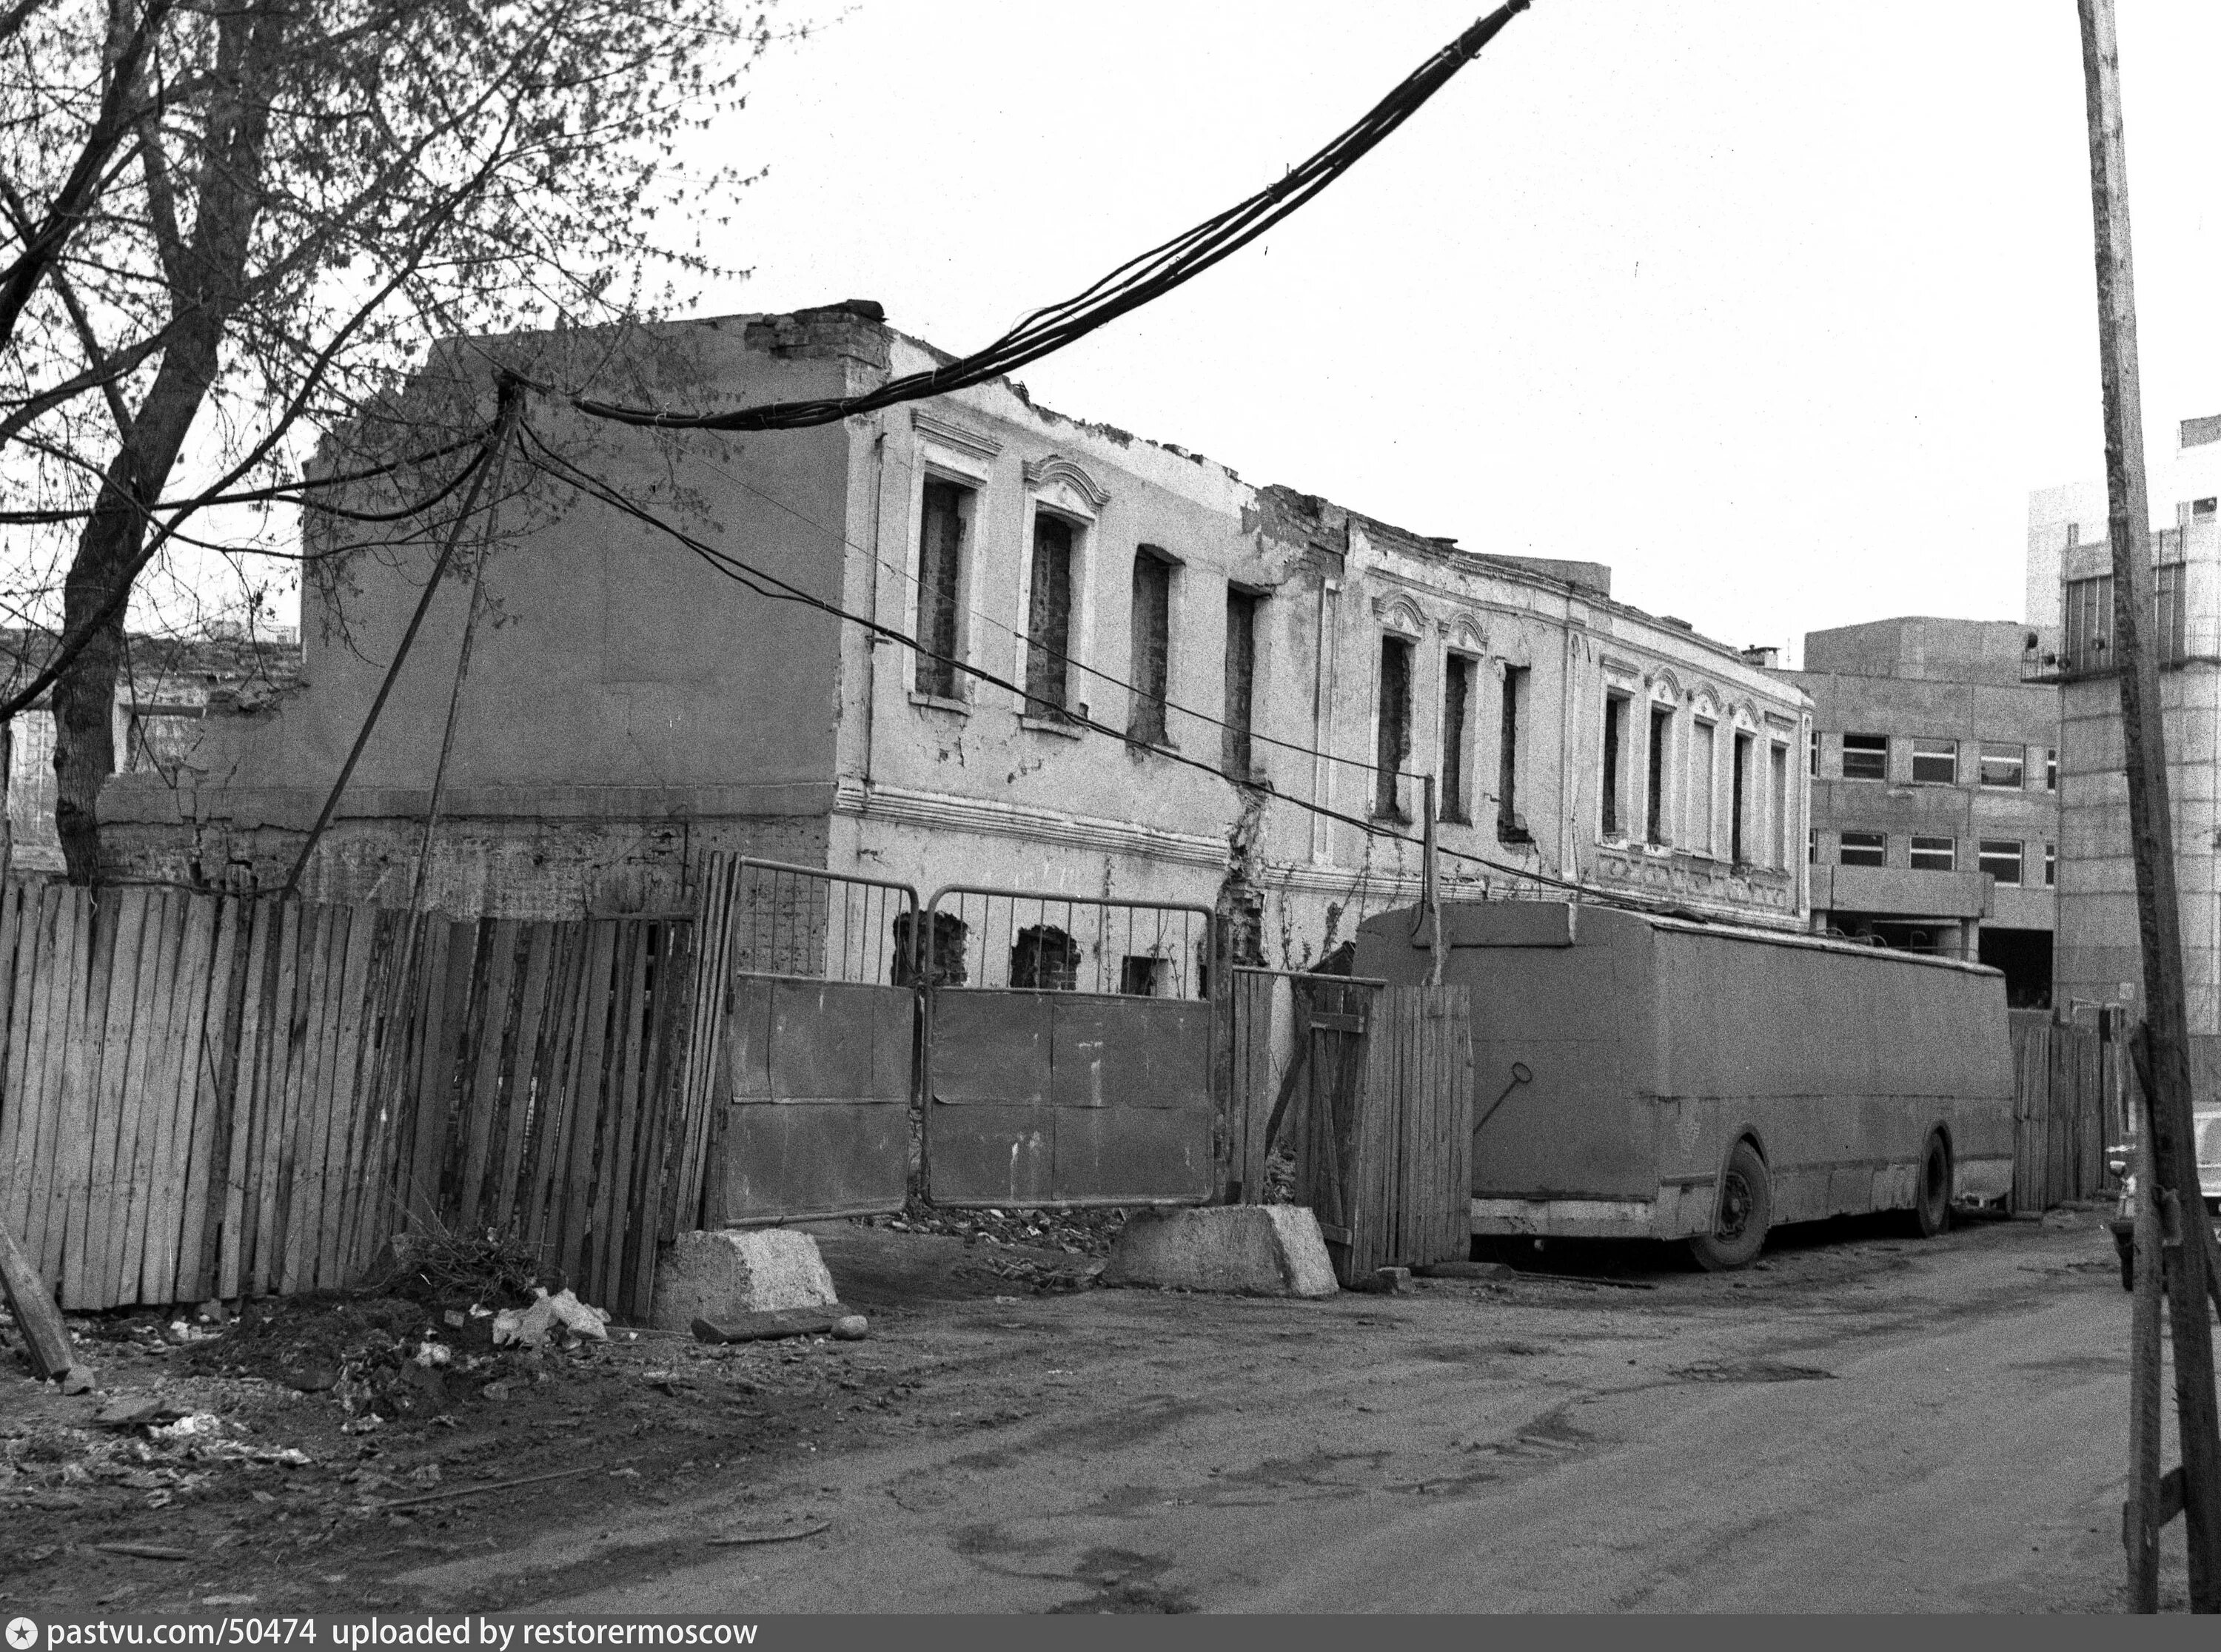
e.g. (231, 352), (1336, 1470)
(2028, 417), (2221, 1070)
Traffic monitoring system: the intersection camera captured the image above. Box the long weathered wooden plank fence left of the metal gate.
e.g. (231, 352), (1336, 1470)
(0, 884), (700, 1317)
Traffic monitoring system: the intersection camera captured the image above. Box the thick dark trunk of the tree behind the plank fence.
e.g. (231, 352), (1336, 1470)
(53, 0), (287, 884)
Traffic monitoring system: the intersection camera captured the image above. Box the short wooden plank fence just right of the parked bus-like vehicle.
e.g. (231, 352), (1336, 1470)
(2012, 1010), (2125, 1210)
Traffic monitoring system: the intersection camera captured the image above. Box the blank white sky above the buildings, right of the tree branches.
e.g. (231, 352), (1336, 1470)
(666, 0), (2221, 671)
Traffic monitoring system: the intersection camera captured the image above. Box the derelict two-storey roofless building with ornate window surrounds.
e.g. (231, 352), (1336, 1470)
(102, 304), (1808, 966)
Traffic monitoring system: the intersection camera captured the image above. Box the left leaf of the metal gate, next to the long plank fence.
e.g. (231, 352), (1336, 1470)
(684, 855), (917, 1228)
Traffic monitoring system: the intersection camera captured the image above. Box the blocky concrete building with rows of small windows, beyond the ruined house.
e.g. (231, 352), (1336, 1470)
(1781, 617), (2059, 1008)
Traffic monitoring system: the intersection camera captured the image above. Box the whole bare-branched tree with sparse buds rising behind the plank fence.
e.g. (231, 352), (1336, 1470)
(0, 0), (773, 882)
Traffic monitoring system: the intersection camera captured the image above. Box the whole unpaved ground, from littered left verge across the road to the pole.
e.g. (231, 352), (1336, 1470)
(0, 1212), (2181, 1614)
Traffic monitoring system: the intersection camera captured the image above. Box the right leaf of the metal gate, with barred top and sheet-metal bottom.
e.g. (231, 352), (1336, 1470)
(919, 886), (1215, 1206)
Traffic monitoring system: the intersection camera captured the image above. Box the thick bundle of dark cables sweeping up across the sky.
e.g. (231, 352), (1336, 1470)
(573, 0), (1530, 431)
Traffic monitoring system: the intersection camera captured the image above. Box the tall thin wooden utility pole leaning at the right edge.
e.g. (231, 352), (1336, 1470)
(2077, 0), (2221, 1612)
